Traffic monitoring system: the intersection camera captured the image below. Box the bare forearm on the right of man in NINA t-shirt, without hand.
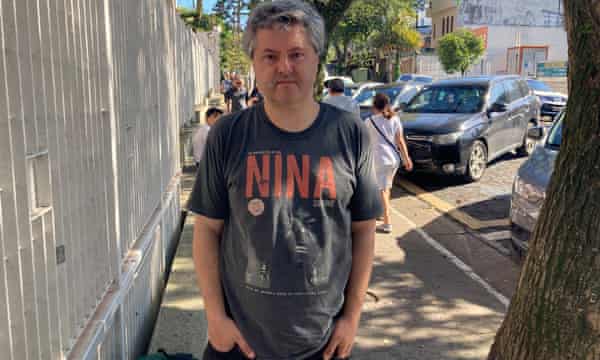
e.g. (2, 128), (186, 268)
(344, 220), (375, 320)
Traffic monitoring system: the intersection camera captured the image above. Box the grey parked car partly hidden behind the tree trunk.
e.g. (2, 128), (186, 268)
(510, 111), (564, 255)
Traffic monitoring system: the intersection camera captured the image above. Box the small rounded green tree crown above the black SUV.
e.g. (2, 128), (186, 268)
(437, 29), (485, 75)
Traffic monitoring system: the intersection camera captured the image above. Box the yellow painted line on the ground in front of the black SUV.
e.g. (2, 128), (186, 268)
(396, 179), (510, 230)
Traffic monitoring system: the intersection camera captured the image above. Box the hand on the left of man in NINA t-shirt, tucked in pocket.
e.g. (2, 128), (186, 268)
(208, 317), (255, 359)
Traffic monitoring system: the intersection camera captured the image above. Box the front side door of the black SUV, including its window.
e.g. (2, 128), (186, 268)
(486, 82), (511, 158)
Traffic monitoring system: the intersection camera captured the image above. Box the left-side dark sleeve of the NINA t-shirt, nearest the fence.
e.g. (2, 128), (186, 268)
(187, 127), (229, 219)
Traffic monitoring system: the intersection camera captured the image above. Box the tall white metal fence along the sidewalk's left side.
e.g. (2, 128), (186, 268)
(0, 0), (219, 360)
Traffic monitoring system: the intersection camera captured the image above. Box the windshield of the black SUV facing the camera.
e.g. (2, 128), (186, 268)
(404, 86), (485, 114)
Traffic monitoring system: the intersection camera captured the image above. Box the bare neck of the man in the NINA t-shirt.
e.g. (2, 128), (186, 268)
(264, 98), (319, 132)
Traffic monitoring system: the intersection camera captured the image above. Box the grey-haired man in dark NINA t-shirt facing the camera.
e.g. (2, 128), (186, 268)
(188, 0), (381, 360)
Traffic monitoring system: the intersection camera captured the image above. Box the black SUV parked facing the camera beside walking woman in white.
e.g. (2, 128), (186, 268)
(401, 75), (540, 181)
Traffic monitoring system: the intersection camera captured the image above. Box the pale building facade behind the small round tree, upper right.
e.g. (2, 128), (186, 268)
(428, 0), (568, 76)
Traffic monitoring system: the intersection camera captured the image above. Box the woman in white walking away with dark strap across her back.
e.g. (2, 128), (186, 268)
(367, 93), (413, 233)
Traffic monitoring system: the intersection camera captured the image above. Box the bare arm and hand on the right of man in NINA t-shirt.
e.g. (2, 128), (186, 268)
(323, 219), (375, 360)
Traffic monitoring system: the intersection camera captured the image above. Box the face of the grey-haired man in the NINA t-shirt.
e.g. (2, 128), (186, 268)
(252, 25), (319, 105)
